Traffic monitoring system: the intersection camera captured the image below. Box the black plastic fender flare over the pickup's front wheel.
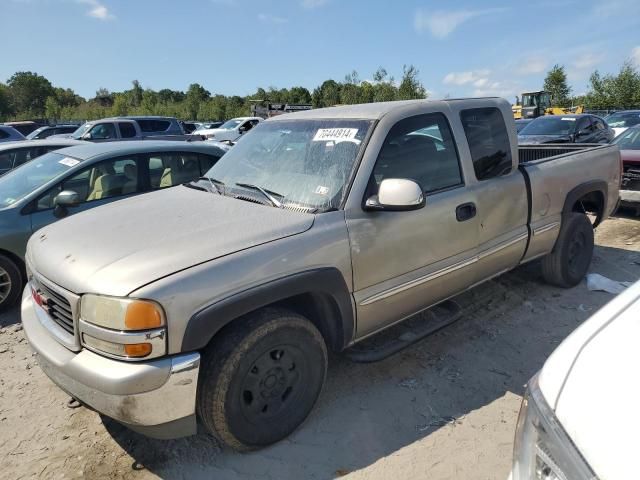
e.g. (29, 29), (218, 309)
(181, 268), (355, 352)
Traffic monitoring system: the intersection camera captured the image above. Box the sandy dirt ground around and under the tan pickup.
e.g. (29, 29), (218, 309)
(0, 218), (640, 480)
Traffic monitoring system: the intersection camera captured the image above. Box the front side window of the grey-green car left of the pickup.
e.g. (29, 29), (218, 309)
(38, 157), (139, 210)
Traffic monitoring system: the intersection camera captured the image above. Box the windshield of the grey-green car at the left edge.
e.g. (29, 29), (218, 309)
(0, 152), (79, 209)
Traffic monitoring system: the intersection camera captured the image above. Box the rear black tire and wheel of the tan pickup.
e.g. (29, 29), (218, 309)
(542, 213), (593, 288)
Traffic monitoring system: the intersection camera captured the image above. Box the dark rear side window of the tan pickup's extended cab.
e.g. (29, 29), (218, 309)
(460, 107), (513, 180)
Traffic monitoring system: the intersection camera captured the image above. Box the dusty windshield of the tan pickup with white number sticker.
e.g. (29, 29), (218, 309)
(207, 119), (372, 210)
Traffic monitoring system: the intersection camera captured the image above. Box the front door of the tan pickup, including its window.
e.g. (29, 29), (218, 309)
(346, 113), (479, 337)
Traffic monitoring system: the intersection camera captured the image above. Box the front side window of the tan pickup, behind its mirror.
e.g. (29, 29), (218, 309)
(369, 113), (463, 195)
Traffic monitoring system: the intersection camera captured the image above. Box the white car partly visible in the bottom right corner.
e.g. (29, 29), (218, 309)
(511, 281), (640, 480)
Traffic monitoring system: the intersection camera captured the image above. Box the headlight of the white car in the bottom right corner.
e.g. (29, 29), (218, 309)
(513, 375), (597, 480)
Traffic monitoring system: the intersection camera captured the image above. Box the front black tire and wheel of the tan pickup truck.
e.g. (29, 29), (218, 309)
(197, 308), (327, 451)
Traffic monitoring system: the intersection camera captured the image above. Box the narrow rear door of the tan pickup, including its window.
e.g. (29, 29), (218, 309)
(460, 107), (529, 284)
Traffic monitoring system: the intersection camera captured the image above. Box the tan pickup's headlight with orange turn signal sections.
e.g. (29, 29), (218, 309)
(79, 294), (166, 360)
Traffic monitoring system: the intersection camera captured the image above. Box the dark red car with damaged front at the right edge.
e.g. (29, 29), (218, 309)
(612, 125), (640, 215)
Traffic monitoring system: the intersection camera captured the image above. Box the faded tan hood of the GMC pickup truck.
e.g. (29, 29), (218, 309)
(27, 186), (315, 296)
